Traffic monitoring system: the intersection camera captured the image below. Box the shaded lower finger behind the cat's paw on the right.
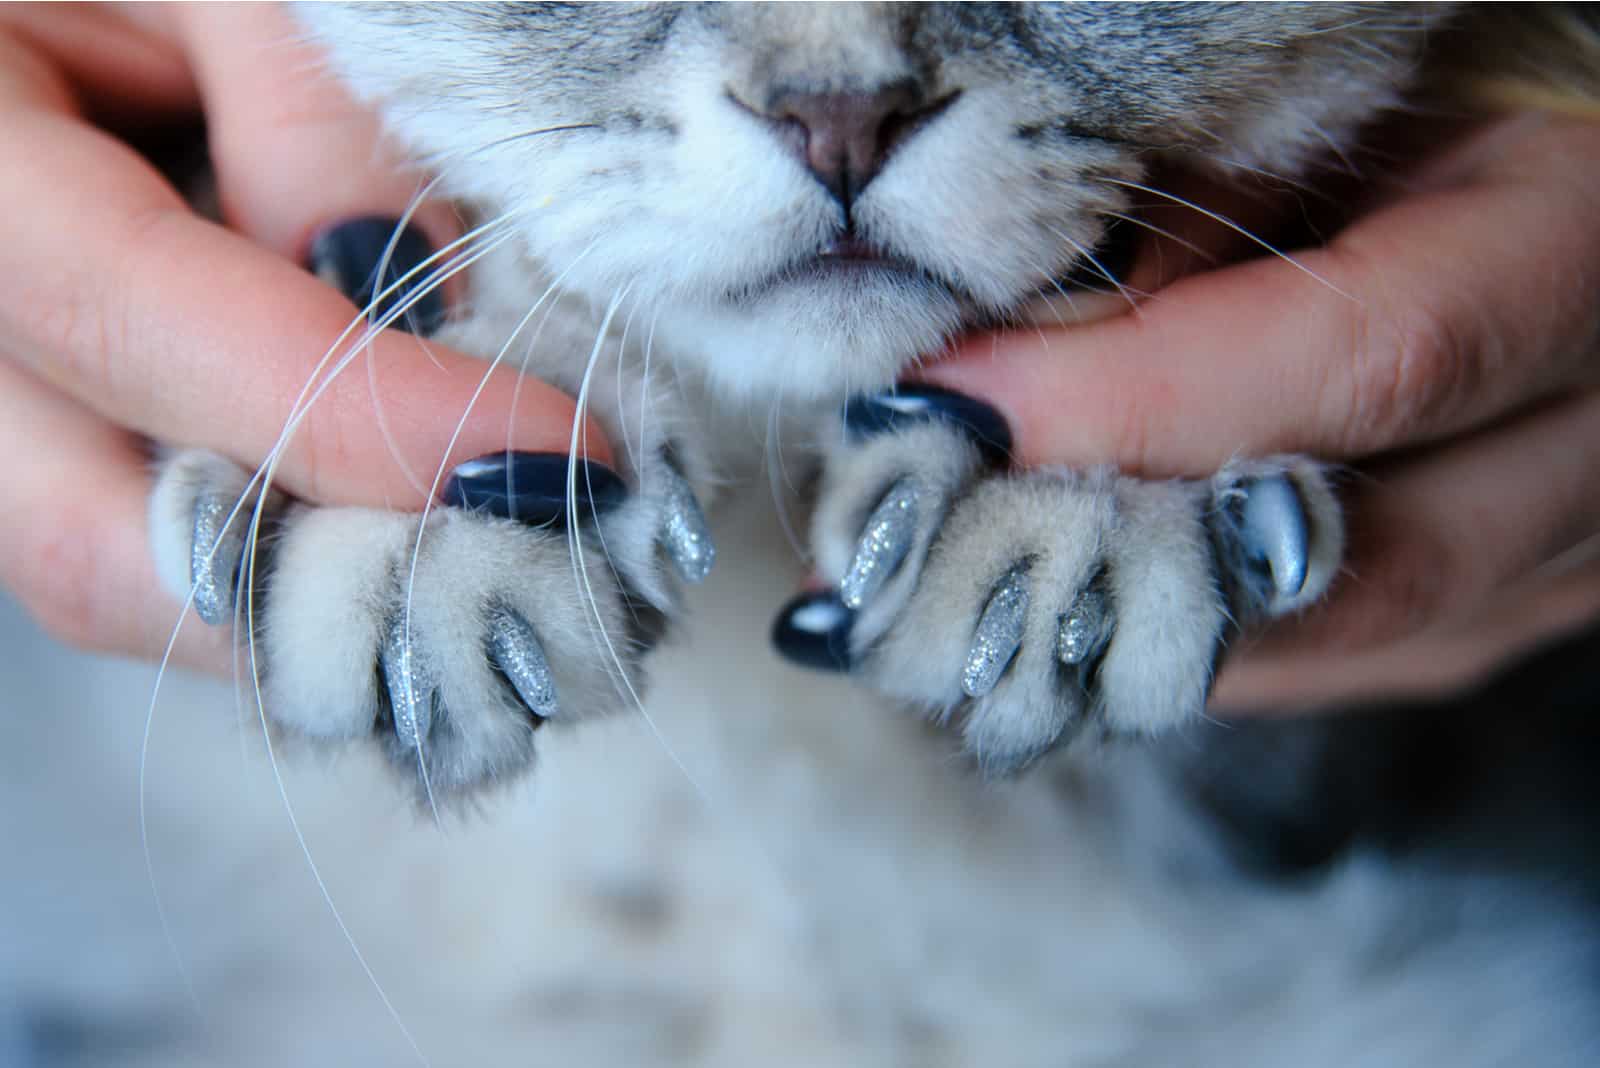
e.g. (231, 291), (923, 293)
(1218, 392), (1600, 705)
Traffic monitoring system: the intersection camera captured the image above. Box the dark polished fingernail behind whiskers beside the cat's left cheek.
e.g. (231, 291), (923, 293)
(307, 216), (445, 337)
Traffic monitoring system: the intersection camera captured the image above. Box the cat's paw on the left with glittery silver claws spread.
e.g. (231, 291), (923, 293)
(150, 452), (714, 798)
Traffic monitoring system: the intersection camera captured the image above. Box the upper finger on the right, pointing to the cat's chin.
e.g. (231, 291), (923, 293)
(922, 117), (1600, 475)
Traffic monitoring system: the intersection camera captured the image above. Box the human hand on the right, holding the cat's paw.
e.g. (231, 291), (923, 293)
(925, 115), (1600, 710)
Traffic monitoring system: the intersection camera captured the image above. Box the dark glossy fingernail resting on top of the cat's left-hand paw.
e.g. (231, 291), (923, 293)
(440, 452), (627, 526)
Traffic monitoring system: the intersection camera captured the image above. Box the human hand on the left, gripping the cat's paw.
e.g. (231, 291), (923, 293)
(0, 5), (610, 670)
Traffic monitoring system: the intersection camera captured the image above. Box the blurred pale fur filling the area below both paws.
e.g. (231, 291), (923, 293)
(0, 502), (1597, 1068)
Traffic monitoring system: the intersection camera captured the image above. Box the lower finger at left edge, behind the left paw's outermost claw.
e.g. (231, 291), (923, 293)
(0, 360), (230, 671)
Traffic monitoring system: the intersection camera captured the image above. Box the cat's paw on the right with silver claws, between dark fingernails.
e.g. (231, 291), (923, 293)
(776, 393), (1342, 774)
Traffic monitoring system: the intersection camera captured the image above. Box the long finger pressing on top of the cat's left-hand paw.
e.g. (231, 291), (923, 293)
(0, 97), (610, 507)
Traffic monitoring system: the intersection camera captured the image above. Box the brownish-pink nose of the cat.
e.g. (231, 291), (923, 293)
(766, 82), (942, 213)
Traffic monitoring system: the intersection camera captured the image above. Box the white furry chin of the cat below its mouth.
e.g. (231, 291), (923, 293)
(646, 285), (971, 403)
